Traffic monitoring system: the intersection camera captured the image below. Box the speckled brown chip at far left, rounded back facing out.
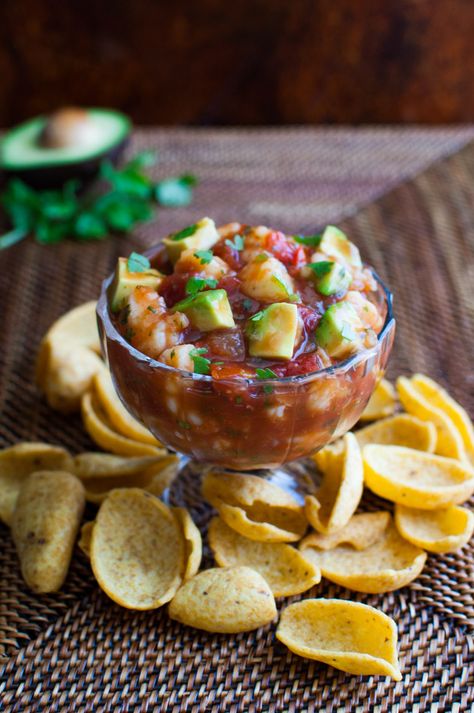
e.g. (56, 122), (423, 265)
(11, 470), (85, 593)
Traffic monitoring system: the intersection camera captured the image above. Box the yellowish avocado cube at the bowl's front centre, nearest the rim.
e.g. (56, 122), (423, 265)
(246, 302), (298, 359)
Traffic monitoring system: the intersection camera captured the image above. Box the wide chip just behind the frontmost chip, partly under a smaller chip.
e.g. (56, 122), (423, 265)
(301, 523), (426, 594)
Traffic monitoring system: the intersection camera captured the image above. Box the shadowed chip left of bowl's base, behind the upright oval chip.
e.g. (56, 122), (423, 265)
(83, 455), (177, 505)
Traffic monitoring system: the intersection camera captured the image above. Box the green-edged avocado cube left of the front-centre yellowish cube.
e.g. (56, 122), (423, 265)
(173, 290), (235, 332)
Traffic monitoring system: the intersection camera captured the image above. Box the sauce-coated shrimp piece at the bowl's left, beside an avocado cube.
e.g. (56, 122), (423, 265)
(127, 286), (189, 358)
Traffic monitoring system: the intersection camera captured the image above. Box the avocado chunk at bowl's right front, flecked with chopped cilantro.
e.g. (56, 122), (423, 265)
(315, 302), (363, 359)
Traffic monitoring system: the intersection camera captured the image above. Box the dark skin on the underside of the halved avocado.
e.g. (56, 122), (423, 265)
(1, 136), (130, 189)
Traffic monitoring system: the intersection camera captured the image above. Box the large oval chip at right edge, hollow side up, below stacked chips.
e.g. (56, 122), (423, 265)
(362, 445), (474, 510)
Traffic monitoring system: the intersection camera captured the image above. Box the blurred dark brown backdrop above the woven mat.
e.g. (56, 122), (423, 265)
(0, 0), (474, 127)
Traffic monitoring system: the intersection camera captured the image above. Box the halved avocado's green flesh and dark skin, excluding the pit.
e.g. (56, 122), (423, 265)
(0, 109), (131, 188)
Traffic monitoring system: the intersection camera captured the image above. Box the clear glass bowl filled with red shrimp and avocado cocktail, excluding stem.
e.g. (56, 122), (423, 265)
(98, 218), (394, 470)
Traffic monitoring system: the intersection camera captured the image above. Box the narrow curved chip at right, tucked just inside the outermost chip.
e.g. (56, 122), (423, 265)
(397, 376), (467, 460)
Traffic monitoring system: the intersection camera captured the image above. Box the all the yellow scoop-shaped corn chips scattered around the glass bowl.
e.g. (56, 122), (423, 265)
(0, 303), (474, 680)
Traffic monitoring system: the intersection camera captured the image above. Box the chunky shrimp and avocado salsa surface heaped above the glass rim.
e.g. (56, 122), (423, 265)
(110, 218), (384, 379)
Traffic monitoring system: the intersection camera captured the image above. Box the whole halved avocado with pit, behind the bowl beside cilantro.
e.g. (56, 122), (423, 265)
(0, 108), (131, 188)
